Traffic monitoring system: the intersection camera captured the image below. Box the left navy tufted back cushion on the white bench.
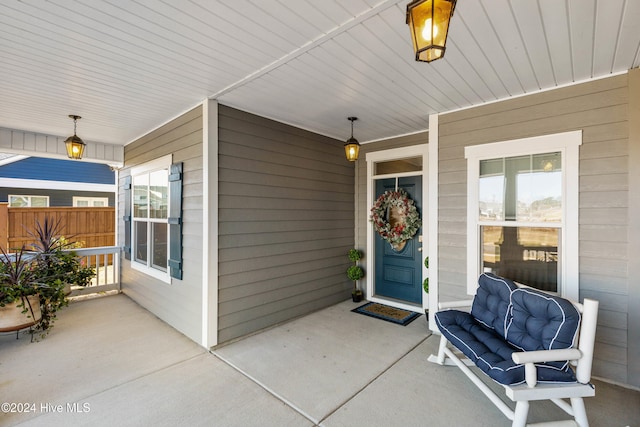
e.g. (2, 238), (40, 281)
(471, 273), (518, 338)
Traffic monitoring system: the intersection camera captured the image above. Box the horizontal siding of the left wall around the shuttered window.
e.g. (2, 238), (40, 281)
(118, 107), (203, 342)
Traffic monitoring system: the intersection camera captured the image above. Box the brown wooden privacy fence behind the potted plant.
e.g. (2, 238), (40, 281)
(0, 203), (116, 252)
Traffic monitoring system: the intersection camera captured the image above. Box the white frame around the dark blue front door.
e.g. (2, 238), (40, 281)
(365, 144), (429, 311)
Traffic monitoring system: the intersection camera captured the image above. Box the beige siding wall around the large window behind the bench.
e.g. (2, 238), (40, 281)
(438, 75), (638, 386)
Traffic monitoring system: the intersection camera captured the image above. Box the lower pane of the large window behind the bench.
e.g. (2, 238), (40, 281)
(480, 226), (560, 292)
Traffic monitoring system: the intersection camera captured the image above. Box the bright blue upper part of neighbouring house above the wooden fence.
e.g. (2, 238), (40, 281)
(0, 157), (115, 184)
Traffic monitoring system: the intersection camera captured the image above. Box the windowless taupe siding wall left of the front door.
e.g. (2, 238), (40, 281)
(218, 105), (354, 343)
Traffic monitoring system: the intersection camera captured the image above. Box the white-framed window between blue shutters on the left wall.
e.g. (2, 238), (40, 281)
(131, 156), (171, 283)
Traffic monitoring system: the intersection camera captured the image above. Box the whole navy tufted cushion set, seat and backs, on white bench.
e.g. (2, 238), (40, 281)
(434, 273), (580, 385)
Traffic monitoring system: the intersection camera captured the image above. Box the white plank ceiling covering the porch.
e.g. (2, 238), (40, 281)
(0, 0), (640, 145)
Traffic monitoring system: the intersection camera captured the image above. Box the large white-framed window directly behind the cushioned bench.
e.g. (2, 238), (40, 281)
(465, 131), (582, 301)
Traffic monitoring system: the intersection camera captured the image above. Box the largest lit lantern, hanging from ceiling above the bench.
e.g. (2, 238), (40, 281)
(407, 0), (456, 62)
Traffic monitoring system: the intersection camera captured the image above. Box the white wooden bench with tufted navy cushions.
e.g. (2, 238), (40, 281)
(429, 274), (598, 427)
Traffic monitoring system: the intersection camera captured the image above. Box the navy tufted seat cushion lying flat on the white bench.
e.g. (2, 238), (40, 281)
(434, 310), (576, 385)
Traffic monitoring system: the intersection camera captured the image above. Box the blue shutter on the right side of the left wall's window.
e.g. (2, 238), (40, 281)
(168, 163), (182, 280)
